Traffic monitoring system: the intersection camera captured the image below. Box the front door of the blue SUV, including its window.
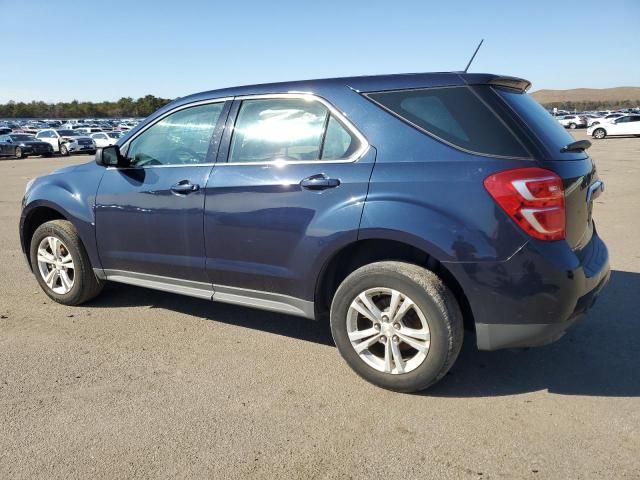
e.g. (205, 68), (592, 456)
(95, 100), (230, 284)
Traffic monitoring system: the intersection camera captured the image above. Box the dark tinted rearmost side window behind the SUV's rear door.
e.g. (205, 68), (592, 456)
(367, 87), (530, 158)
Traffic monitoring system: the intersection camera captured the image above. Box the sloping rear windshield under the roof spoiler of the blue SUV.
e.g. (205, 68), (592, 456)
(495, 88), (585, 160)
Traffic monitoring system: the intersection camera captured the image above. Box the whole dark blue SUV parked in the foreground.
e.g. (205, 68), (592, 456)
(20, 72), (609, 391)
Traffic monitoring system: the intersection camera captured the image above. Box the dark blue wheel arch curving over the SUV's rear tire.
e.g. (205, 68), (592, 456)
(314, 238), (475, 331)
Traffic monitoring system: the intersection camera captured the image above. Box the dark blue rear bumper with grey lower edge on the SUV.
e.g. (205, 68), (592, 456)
(447, 230), (610, 350)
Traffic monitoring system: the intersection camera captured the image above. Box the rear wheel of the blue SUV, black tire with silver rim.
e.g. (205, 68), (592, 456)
(330, 261), (464, 392)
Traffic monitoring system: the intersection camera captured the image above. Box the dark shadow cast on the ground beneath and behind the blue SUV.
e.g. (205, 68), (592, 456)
(91, 271), (640, 397)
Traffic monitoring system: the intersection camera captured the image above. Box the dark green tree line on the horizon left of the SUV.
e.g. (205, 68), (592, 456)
(0, 95), (171, 118)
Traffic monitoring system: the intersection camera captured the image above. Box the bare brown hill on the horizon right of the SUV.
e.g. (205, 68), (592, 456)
(531, 87), (640, 107)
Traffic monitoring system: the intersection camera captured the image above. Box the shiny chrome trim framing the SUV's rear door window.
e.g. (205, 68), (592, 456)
(216, 92), (369, 167)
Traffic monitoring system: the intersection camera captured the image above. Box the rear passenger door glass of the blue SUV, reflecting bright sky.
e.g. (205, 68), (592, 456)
(228, 98), (360, 163)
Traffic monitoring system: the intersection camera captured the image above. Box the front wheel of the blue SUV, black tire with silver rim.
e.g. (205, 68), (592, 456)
(29, 220), (104, 305)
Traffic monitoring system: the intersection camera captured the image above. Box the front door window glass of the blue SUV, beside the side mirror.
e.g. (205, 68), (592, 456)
(127, 102), (224, 166)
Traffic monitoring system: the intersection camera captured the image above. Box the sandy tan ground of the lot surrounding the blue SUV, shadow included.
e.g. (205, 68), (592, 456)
(0, 132), (640, 479)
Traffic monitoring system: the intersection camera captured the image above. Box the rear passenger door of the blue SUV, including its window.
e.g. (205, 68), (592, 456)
(205, 94), (375, 300)
